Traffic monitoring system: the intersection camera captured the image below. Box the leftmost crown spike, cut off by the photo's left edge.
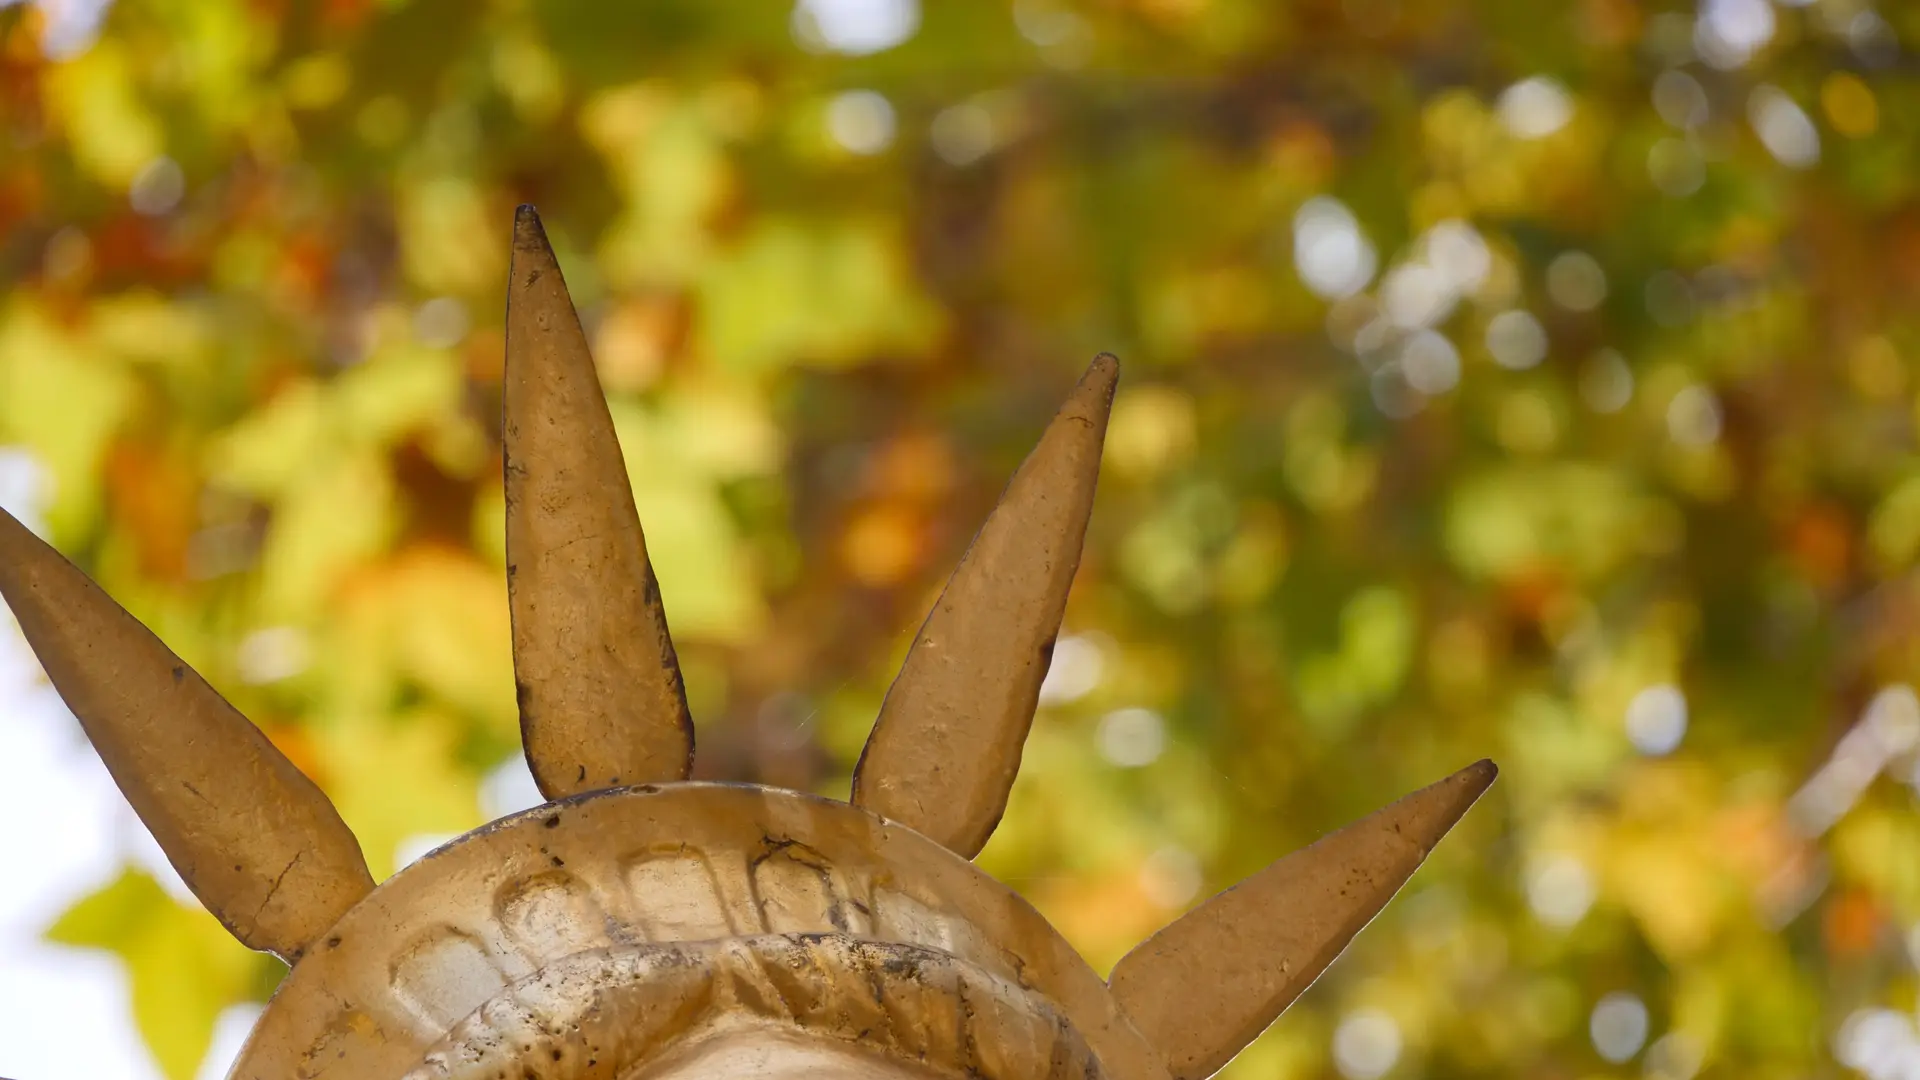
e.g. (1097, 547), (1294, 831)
(0, 511), (372, 949)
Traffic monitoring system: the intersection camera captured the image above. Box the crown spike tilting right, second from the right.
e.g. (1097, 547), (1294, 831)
(852, 354), (1119, 857)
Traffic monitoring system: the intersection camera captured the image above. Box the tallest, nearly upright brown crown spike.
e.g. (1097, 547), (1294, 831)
(501, 206), (693, 799)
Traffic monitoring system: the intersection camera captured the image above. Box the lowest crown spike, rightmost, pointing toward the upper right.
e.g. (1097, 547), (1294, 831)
(1108, 761), (1500, 1080)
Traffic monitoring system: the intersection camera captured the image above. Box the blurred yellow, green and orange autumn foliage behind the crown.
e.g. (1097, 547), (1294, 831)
(0, 0), (1920, 1080)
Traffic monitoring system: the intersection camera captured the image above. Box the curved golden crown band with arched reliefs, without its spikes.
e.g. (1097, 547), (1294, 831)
(238, 784), (1165, 1080)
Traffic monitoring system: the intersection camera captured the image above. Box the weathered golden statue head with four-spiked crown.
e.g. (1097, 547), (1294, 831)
(0, 208), (1494, 1080)
